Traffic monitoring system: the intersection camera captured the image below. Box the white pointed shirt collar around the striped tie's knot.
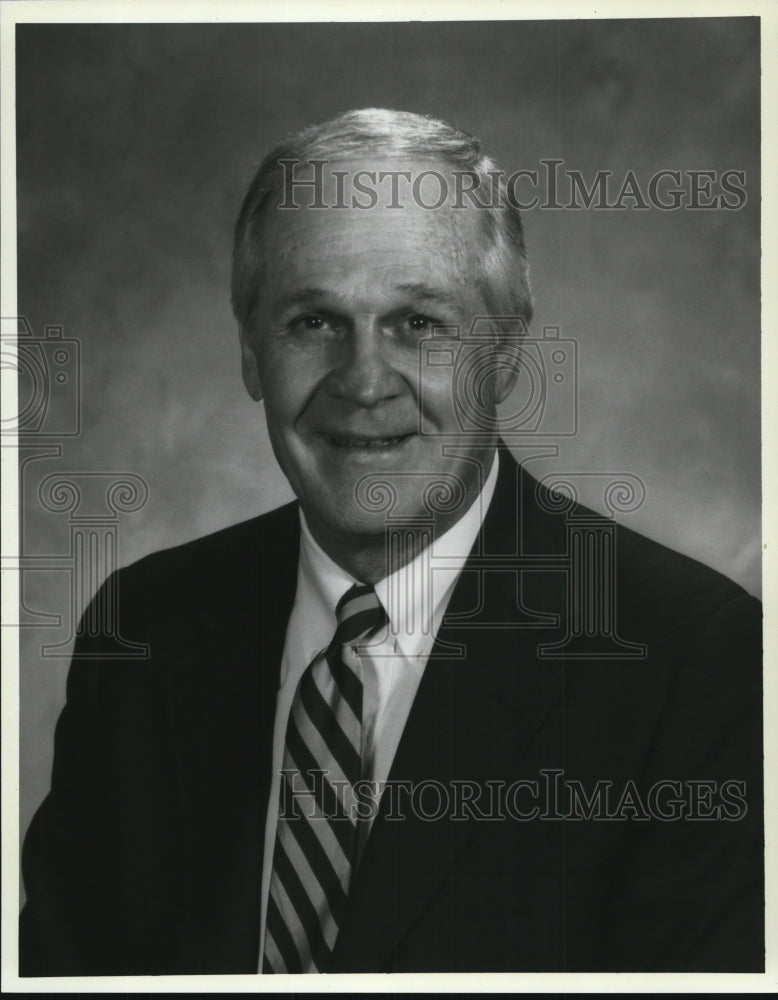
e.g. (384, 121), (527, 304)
(298, 451), (499, 659)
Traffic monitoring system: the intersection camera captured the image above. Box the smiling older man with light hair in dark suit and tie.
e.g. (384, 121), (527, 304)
(21, 110), (763, 975)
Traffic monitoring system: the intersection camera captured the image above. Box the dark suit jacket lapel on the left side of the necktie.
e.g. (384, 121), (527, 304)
(161, 507), (299, 971)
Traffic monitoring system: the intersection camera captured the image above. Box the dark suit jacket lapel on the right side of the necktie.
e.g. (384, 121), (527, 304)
(332, 454), (565, 972)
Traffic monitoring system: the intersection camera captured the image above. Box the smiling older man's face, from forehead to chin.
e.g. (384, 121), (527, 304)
(236, 156), (514, 541)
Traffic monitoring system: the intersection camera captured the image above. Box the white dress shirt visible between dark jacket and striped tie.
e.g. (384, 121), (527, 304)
(259, 453), (498, 956)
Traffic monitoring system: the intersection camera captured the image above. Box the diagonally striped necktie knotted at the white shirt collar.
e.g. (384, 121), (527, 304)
(262, 584), (387, 973)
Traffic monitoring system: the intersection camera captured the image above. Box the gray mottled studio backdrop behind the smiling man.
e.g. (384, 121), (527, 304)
(17, 19), (760, 852)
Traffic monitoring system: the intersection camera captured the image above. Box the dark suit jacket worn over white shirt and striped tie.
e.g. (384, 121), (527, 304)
(21, 450), (764, 975)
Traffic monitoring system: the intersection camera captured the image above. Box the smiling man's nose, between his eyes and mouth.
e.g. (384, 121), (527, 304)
(326, 320), (405, 409)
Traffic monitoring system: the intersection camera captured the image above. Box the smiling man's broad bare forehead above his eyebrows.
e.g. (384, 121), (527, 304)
(252, 157), (485, 308)
